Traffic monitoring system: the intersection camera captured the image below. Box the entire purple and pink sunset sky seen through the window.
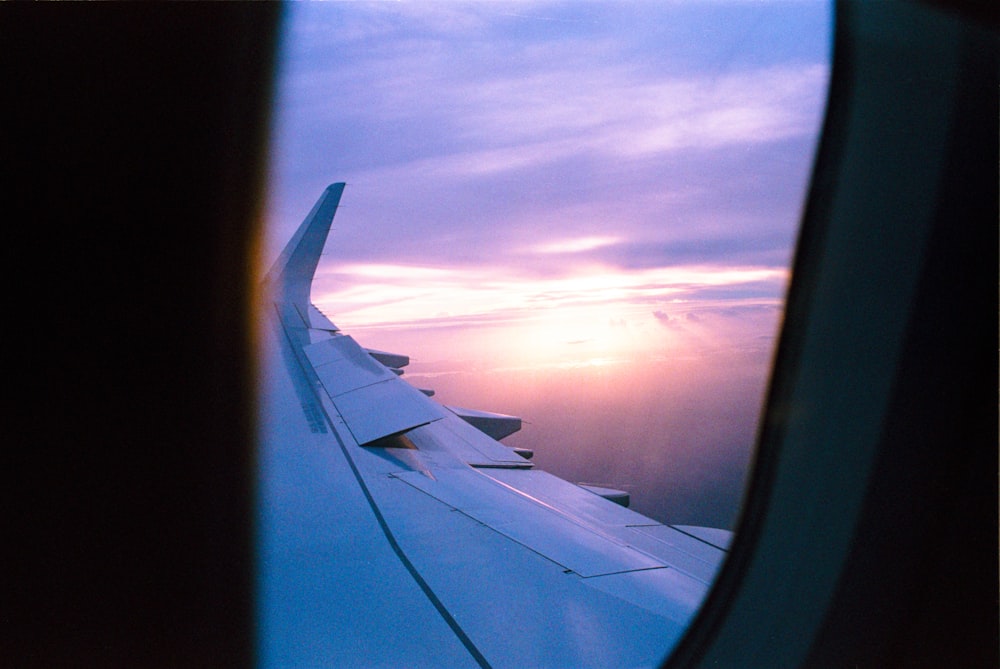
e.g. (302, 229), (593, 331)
(265, 0), (831, 528)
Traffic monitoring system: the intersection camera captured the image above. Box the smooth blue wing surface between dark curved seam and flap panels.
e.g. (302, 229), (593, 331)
(364, 475), (705, 669)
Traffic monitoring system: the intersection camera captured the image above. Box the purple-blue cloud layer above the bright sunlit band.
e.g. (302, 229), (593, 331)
(268, 3), (827, 288)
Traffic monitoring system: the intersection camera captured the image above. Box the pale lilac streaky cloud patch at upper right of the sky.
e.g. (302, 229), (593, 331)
(458, 62), (827, 160)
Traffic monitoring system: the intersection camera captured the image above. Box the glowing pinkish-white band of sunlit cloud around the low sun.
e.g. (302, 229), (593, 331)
(315, 264), (788, 371)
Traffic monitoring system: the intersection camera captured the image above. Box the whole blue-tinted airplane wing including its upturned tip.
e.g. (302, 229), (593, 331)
(258, 183), (728, 667)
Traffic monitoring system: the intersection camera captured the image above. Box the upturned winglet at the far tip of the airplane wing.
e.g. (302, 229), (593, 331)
(265, 182), (344, 313)
